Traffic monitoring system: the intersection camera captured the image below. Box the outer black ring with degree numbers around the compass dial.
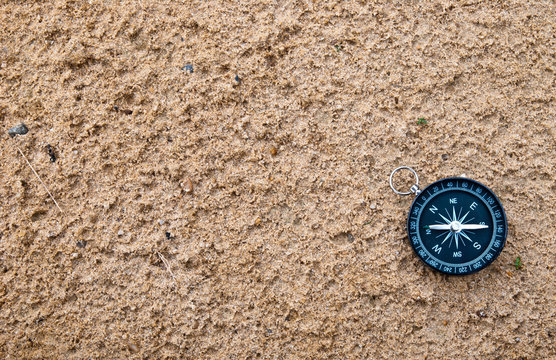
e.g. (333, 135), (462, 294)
(407, 177), (508, 275)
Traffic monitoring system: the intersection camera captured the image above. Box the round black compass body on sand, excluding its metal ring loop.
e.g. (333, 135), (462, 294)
(407, 178), (507, 275)
